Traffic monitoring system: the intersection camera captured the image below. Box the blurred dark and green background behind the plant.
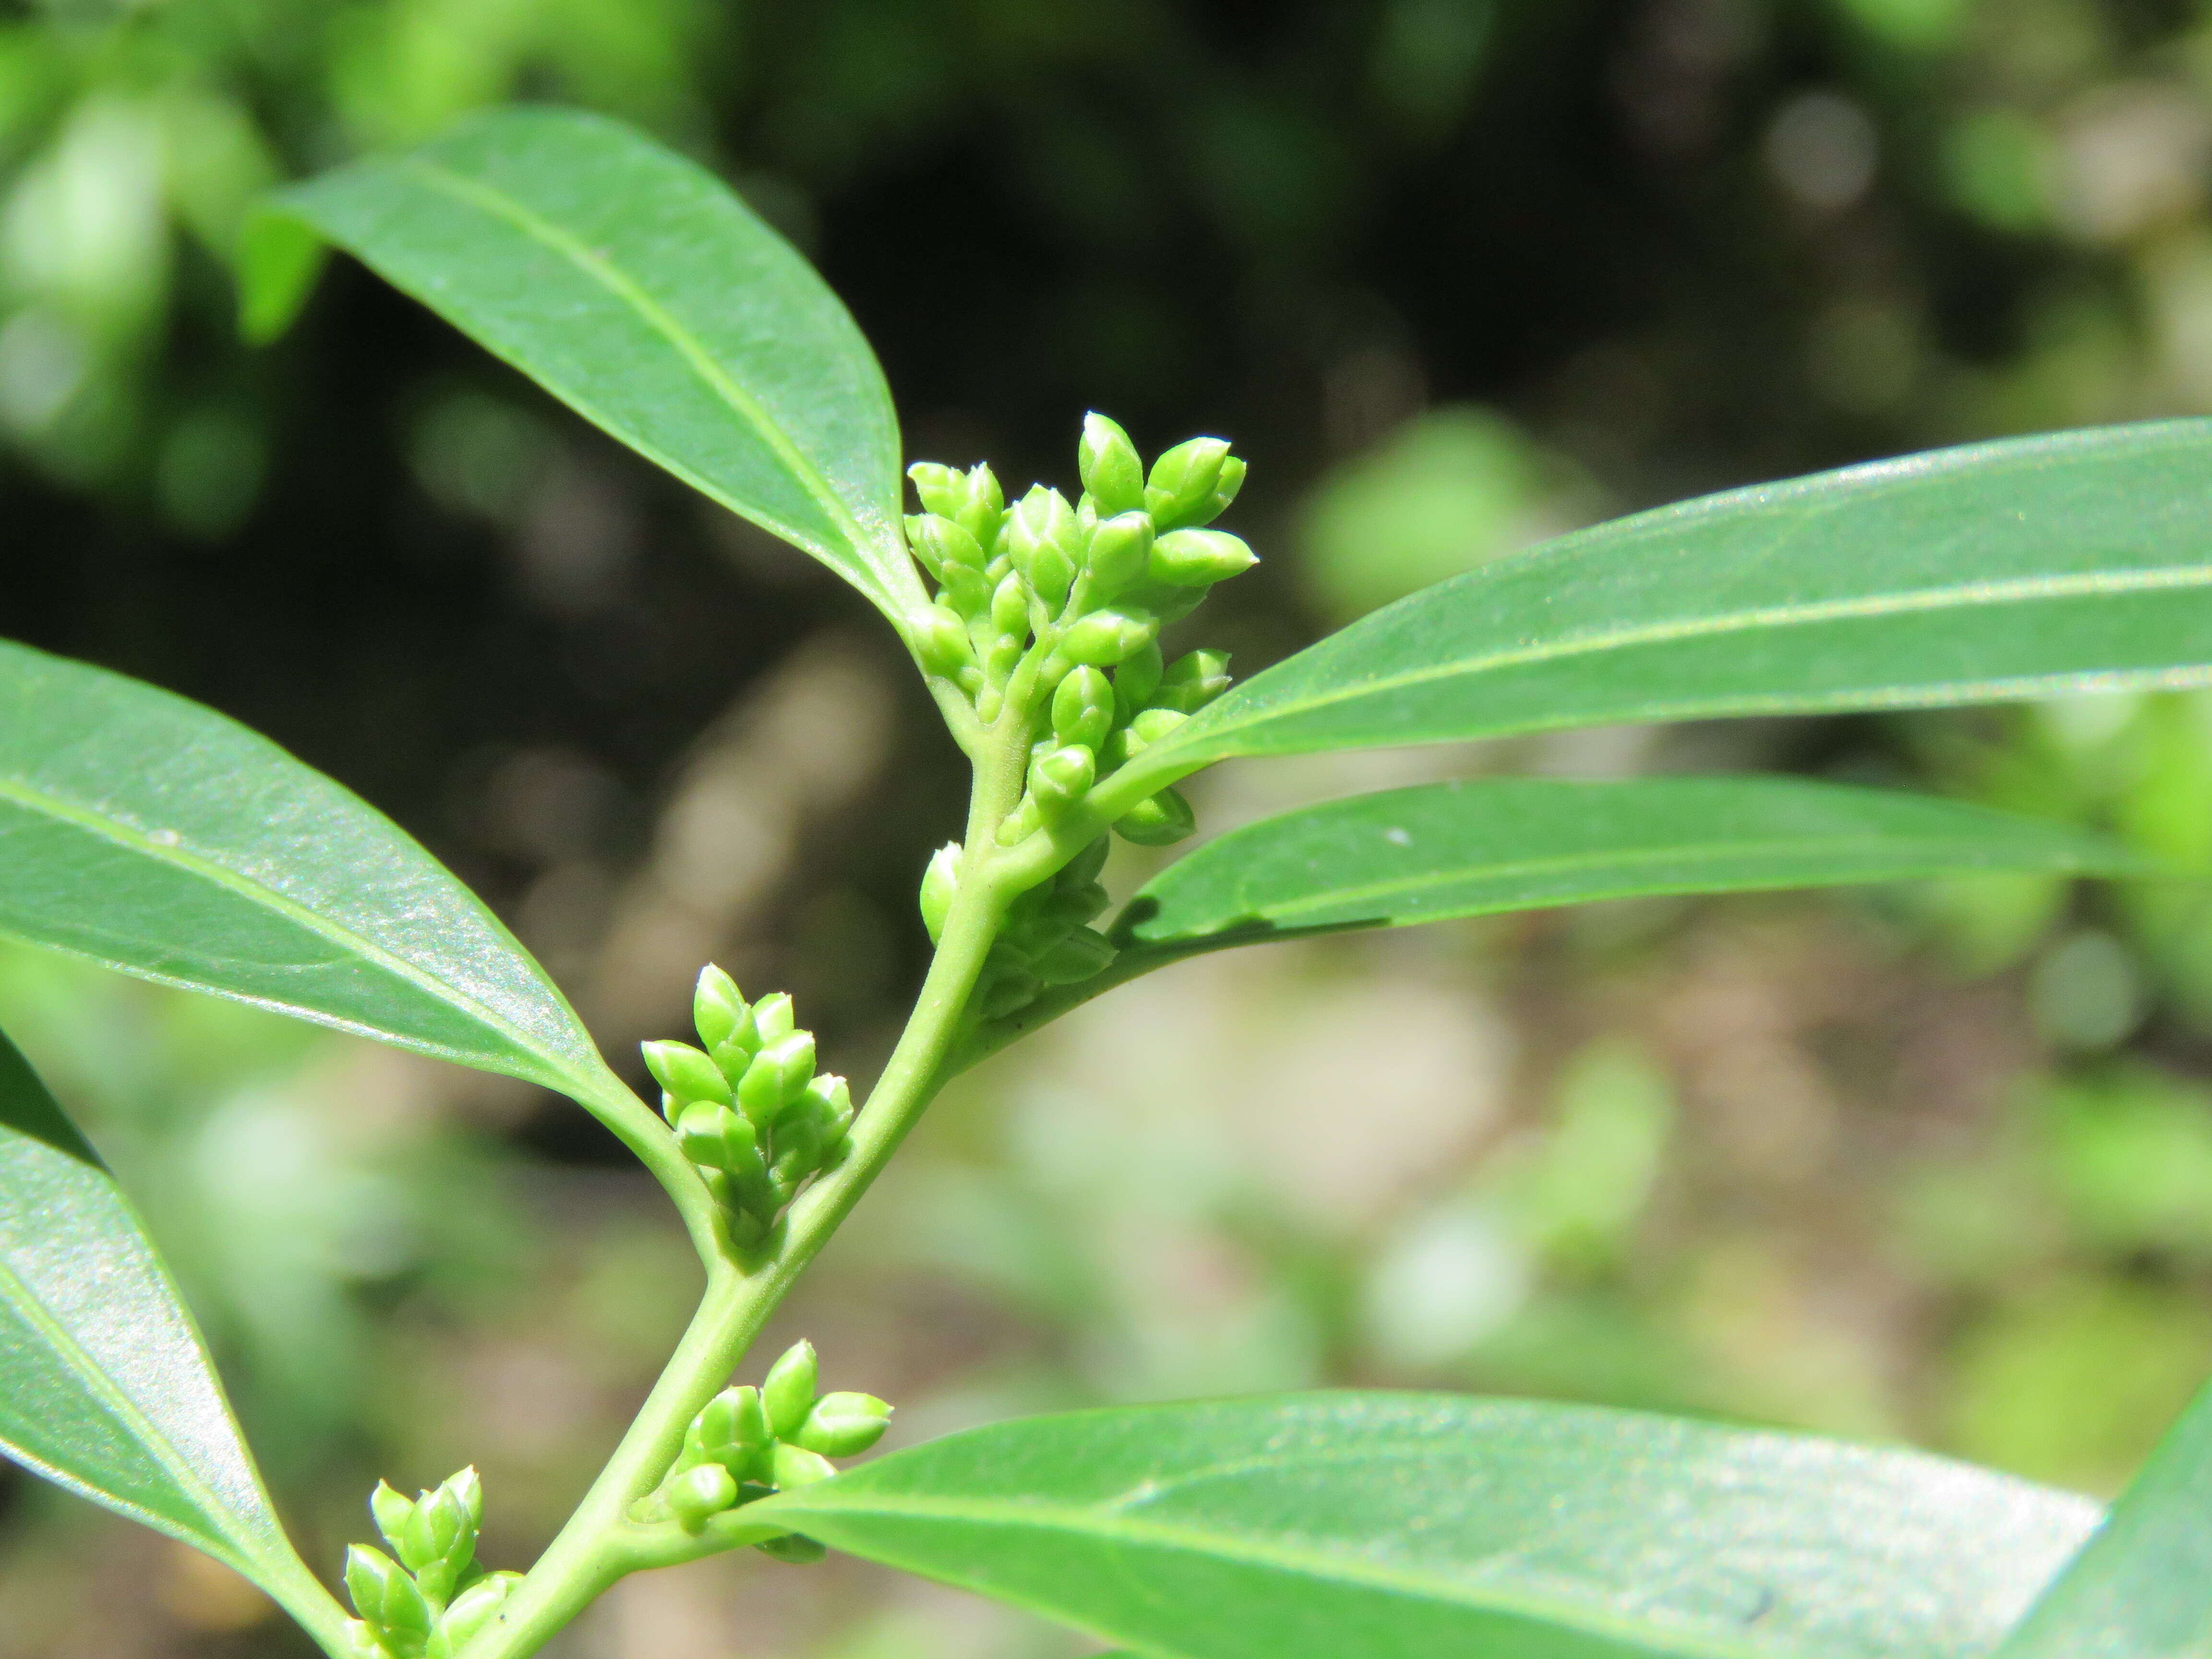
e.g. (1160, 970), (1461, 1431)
(0, 0), (2212, 1659)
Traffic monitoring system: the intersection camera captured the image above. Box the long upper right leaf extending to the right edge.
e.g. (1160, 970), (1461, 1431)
(1110, 421), (2212, 801)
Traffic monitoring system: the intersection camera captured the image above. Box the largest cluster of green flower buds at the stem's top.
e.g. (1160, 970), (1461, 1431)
(907, 414), (1256, 845)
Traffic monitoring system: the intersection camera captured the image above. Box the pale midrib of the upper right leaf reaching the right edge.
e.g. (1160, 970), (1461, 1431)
(1177, 564), (2212, 757)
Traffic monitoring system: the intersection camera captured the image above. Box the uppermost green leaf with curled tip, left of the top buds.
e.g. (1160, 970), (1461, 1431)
(241, 108), (923, 622)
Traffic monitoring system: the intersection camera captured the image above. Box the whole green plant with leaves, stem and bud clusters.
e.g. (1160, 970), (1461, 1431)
(0, 97), (2212, 1659)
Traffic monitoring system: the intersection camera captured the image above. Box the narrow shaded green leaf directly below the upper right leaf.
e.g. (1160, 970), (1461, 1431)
(1115, 776), (2132, 953)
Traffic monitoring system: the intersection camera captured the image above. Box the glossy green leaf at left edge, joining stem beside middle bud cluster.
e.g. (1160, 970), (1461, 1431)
(0, 641), (619, 1095)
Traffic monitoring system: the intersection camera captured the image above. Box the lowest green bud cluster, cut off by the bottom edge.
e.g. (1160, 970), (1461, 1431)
(345, 1469), (522, 1659)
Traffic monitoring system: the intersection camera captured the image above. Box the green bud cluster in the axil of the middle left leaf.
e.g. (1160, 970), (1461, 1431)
(644, 962), (852, 1243)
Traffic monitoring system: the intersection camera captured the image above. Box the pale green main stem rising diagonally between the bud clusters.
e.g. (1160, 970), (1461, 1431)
(465, 706), (1029, 1659)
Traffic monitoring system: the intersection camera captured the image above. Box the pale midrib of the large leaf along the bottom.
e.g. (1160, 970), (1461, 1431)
(769, 1495), (1772, 1659)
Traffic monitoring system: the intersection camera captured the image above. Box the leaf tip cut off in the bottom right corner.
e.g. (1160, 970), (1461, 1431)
(1997, 1387), (2212, 1659)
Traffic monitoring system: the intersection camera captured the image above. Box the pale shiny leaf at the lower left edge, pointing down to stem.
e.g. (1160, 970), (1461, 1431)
(0, 1035), (345, 1650)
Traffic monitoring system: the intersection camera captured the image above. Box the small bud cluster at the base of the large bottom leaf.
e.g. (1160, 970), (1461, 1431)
(630, 1343), (891, 1562)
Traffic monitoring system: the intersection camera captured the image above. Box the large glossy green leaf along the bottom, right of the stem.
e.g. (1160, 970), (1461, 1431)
(748, 1394), (2097, 1659)
